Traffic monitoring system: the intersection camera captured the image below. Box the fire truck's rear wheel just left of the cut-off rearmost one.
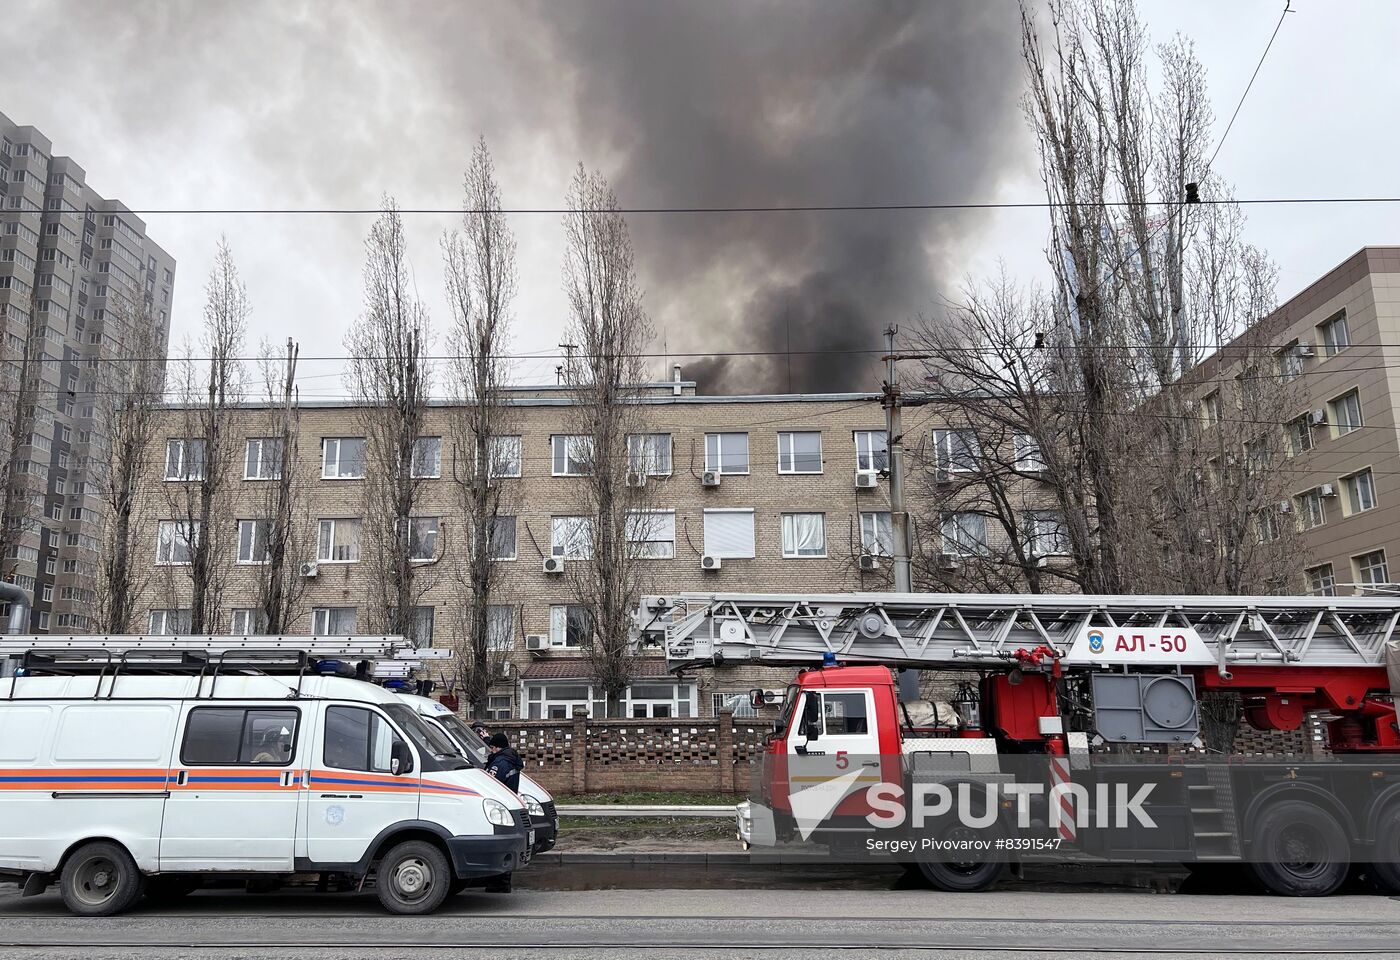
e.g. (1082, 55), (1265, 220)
(1249, 800), (1351, 897)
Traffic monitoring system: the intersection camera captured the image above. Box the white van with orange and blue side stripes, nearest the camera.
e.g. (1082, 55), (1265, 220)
(0, 673), (533, 917)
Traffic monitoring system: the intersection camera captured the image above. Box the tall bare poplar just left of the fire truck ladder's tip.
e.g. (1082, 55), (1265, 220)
(564, 164), (655, 714)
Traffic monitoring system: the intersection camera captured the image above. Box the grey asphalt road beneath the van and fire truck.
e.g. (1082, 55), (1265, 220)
(0, 884), (1400, 960)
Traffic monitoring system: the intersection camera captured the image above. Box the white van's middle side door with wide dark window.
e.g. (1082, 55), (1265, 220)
(161, 704), (301, 872)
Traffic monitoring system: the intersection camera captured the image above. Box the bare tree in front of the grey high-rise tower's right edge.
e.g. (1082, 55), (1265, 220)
(88, 289), (165, 634)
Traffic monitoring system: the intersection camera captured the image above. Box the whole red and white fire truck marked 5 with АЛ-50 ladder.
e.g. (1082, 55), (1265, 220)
(638, 593), (1400, 896)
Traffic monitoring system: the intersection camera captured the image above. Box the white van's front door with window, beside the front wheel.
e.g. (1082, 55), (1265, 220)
(305, 704), (419, 869)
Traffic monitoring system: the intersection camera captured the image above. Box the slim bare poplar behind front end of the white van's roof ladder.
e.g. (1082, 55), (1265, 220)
(346, 196), (442, 641)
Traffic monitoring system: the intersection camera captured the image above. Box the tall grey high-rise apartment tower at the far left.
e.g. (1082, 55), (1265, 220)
(0, 115), (175, 633)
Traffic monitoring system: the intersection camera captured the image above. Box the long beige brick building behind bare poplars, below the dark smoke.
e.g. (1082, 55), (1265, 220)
(133, 368), (1069, 718)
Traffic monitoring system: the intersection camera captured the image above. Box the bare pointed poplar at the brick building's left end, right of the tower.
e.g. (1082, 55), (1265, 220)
(158, 239), (249, 634)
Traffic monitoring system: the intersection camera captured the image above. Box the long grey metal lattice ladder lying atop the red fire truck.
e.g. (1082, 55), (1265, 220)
(637, 593), (1400, 675)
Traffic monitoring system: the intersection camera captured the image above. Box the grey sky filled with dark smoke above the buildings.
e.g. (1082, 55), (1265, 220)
(0, 0), (1400, 396)
